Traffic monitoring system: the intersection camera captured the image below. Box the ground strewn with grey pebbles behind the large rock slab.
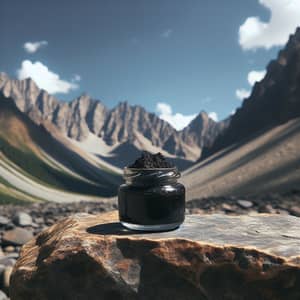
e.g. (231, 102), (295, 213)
(0, 196), (300, 294)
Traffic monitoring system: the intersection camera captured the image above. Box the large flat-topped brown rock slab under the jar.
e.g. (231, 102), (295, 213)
(10, 212), (300, 300)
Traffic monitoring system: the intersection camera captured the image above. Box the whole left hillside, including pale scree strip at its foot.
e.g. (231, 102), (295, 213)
(0, 95), (121, 201)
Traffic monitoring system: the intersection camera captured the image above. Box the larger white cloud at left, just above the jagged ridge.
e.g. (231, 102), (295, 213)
(17, 60), (78, 94)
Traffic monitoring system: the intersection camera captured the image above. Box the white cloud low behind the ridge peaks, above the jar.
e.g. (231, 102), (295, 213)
(156, 102), (197, 130)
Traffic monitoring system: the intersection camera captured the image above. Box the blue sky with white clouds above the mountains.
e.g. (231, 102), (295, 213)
(0, 0), (300, 128)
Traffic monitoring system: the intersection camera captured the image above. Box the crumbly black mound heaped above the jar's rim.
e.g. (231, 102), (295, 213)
(128, 151), (174, 169)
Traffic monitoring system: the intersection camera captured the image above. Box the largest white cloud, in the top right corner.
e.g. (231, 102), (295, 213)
(239, 0), (300, 50)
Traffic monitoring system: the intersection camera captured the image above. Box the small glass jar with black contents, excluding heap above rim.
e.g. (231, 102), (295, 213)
(118, 167), (185, 231)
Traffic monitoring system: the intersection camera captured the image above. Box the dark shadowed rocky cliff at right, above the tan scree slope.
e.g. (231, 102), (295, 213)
(202, 28), (300, 159)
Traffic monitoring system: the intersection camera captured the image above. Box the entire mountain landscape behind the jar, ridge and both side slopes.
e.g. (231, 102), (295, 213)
(0, 28), (300, 202)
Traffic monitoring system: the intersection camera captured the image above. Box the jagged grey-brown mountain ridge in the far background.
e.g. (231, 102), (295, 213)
(0, 73), (228, 167)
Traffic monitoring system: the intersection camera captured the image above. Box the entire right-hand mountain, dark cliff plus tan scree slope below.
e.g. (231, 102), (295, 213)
(183, 28), (300, 198)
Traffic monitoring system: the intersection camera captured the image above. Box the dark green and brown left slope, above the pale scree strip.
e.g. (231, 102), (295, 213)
(0, 95), (119, 198)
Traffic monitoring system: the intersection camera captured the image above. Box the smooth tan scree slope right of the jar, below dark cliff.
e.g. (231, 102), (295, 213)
(182, 118), (300, 199)
